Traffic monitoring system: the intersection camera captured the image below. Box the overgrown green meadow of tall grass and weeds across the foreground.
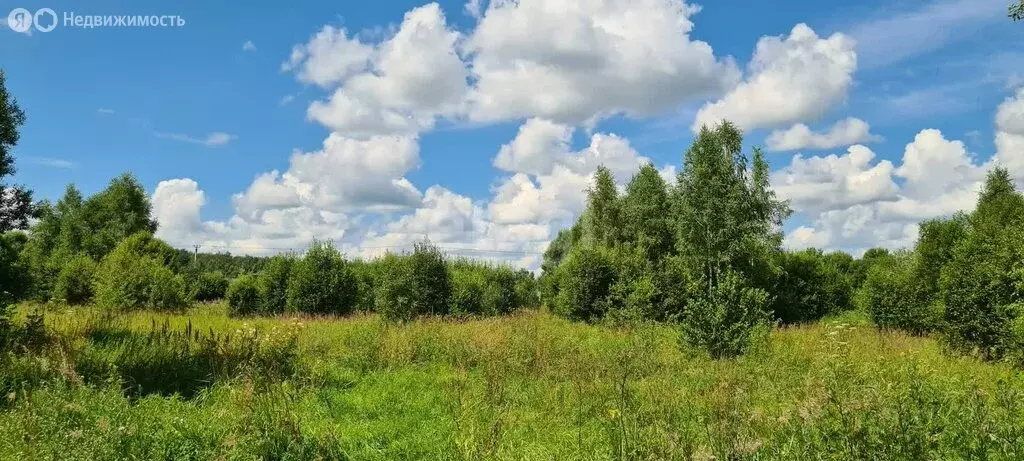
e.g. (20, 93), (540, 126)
(0, 304), (1024, 460)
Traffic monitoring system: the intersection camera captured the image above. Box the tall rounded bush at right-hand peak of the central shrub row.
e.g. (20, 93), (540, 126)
(375, 242), (452, 321)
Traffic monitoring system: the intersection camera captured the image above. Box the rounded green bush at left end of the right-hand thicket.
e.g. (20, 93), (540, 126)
(858, 254), (941, 335)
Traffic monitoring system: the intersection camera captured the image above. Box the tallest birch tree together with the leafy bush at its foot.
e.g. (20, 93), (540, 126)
(676, 122), (790, 357)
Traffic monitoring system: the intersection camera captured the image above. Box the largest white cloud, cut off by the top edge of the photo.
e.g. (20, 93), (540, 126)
(465, 0), (739, 124)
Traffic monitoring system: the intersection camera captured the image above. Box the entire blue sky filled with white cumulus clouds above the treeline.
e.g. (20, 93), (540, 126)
(0, 0), (1024, 268)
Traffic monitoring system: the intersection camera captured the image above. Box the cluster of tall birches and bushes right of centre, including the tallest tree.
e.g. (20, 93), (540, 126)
(542, 123), (857, 357)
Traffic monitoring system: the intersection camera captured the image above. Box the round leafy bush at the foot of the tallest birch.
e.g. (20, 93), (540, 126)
(680, 271), (769, 359)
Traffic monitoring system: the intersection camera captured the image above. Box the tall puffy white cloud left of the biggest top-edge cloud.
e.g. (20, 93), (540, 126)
(296, 3), (468, 137)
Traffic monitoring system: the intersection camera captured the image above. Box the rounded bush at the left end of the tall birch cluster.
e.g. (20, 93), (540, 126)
(555, 246), (617, 321)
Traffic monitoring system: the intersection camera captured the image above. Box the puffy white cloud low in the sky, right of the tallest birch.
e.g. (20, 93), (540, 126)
(772, 129), (991, 251)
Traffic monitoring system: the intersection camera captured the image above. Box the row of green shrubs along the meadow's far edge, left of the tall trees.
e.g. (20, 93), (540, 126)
(227, 242), (538, 321)
